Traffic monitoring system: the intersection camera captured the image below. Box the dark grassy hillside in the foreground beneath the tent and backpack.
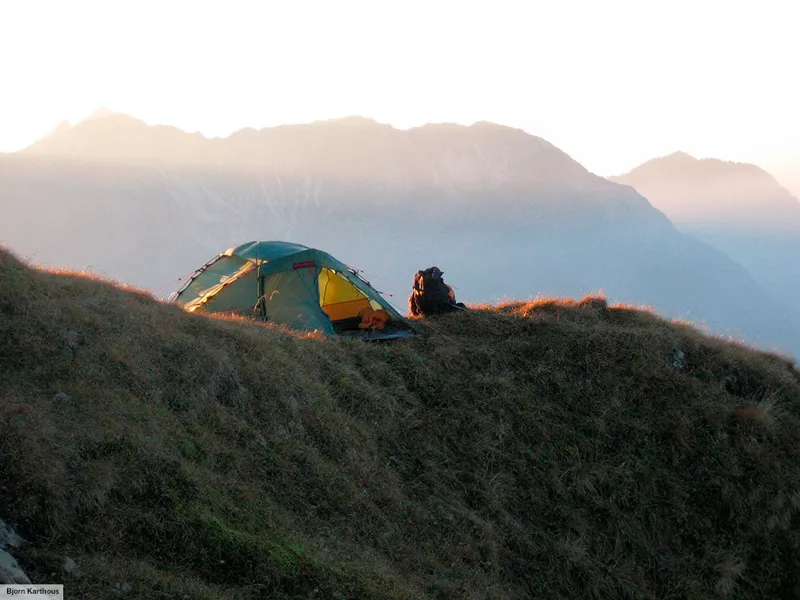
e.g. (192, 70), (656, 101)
(0, 246), (800, 600)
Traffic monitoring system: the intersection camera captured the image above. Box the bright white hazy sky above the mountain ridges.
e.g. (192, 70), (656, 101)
(0, 0), (800, 195)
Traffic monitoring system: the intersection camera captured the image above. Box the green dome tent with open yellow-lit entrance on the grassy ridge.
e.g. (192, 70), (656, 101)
(170, 242), (413, 339)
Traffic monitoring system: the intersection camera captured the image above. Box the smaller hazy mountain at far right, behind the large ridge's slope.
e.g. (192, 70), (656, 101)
(612, 152), (800, 307)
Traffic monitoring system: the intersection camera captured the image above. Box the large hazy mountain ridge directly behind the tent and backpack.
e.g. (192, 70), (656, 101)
(0, 114), (797, 356)
